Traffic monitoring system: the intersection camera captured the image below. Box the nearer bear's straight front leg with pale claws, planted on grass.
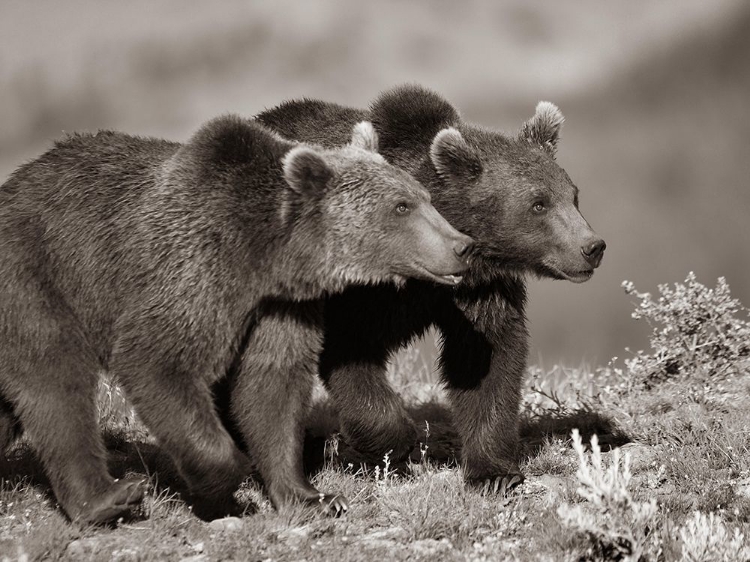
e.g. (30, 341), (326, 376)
(230, 302), (349, 515)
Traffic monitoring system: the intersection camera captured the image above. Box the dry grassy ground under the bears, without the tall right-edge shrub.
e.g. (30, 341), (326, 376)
(0, 356), (750, 561)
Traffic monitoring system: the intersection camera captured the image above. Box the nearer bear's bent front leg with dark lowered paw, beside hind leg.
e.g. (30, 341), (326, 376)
(110, 315), (250, 520)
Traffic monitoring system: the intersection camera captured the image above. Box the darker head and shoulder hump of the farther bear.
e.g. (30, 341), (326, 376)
(372, 86), (605, 283)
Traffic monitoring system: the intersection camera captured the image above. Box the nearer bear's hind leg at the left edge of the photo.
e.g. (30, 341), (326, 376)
(0, 306), (144, 524)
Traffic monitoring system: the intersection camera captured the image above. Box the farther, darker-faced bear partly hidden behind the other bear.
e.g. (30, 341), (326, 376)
(257, 86), (605, 488)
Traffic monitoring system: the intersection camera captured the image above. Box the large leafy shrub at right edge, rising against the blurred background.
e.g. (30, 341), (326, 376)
(622, 271), (750, 383)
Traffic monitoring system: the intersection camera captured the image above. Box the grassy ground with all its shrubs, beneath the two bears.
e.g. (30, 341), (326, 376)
(0, 275), (750, 562)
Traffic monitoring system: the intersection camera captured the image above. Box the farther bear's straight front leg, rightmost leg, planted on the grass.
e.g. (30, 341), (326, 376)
(440, 286), (527, 492)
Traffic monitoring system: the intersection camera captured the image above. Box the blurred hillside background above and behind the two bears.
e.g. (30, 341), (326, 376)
(0, 0), (750, 367)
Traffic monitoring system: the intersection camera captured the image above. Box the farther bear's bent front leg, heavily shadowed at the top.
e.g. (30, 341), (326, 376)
(320, 282), (432, 464)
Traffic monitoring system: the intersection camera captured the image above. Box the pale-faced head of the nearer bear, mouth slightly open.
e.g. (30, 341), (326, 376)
(279, 122), (473, 285)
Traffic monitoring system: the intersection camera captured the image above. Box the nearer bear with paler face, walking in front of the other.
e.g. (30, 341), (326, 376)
(0, 116), (471, 522)
